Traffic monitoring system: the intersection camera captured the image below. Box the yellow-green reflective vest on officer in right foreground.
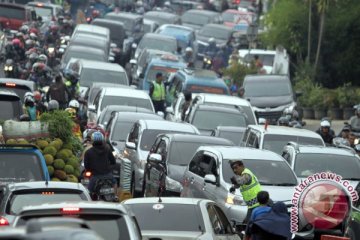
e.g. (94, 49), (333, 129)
(240, 168), (261, 208)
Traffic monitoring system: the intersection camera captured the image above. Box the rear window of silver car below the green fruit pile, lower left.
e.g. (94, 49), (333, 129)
(7, 192), (87, 215)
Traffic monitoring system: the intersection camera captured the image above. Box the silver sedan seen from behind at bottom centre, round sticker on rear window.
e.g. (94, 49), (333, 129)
(123, 197), (241, 240)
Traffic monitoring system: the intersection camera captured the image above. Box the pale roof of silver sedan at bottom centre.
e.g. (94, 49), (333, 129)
(122, 197), (213, 205)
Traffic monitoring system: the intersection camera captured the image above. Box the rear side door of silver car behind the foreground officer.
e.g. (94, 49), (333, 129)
(181, 151), (205, 198)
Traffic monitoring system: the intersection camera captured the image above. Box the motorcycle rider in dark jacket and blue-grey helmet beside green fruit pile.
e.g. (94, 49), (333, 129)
(84, 132), (117, 199)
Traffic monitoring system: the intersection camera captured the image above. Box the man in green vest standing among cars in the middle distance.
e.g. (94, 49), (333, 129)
(149, 72), (166, 114)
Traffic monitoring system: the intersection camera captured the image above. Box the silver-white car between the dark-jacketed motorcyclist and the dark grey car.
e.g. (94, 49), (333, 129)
(122, 120), (200, 197)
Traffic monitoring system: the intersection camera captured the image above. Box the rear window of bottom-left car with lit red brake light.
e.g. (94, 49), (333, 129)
(16, 213), (130, 240)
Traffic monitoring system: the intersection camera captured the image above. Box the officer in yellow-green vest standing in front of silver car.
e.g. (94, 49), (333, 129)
(229, 160), (261, 227)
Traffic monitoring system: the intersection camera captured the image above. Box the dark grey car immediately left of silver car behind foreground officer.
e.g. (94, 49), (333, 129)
(143, 134), (233, 197)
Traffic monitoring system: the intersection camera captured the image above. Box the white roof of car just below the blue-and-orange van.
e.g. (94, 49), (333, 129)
(194, 93), (251, 106)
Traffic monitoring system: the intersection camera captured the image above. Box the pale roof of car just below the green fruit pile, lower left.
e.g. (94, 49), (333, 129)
(7, 181), (86, 191)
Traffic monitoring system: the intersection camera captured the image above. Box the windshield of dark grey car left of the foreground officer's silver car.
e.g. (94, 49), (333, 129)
(167, 140), (228, 166)
